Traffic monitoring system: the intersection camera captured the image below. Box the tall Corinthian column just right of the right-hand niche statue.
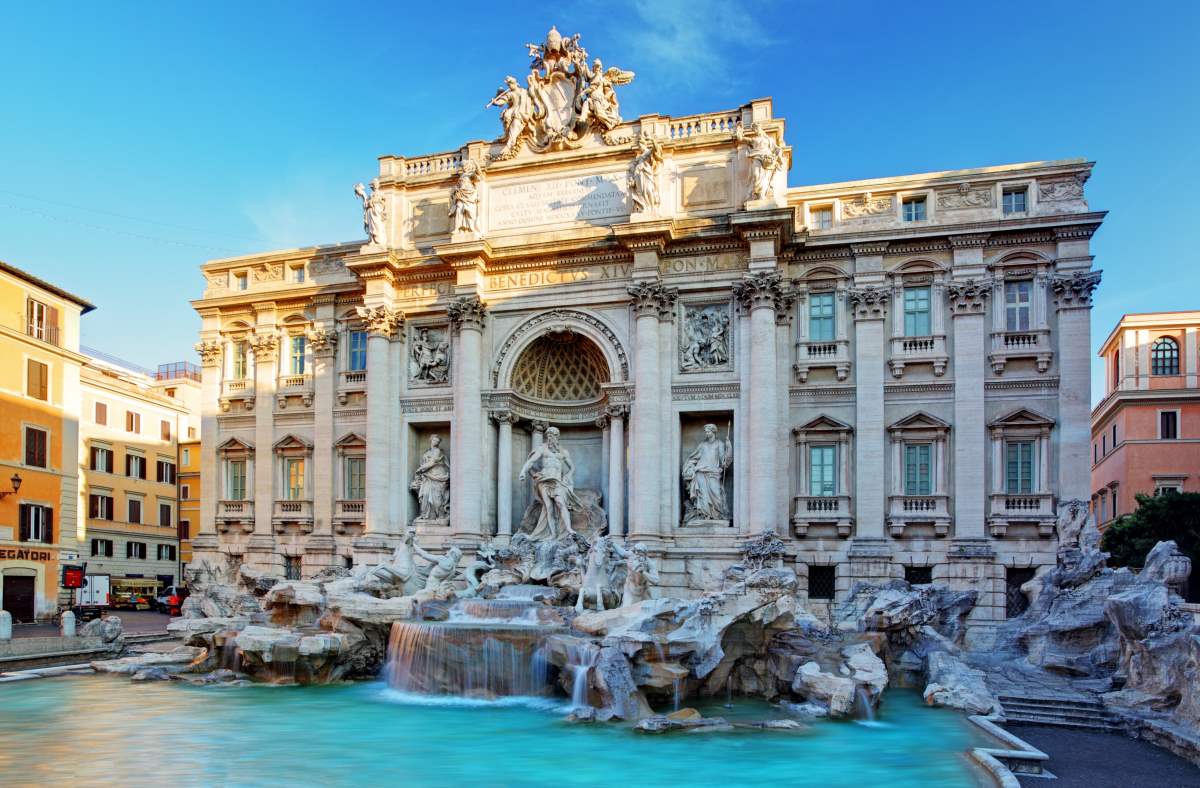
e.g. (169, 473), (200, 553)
(733, 271), (784, 531)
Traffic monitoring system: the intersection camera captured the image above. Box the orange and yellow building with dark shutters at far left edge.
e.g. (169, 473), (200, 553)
(0, 261), (95, 622)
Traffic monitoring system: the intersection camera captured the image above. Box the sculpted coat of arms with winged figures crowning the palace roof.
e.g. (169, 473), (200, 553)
(487, 28), (634, 160)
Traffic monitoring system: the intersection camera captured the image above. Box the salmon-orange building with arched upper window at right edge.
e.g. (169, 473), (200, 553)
(1092, 312), (1200, 528)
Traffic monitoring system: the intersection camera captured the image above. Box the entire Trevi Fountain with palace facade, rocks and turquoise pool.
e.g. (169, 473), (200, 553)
(0, 23), (1200, 787)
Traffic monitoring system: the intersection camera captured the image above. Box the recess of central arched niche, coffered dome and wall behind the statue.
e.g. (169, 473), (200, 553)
(510, 329), (612, 529)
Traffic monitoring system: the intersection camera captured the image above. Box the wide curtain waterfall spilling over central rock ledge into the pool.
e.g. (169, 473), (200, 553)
(385, 621), (550, 698)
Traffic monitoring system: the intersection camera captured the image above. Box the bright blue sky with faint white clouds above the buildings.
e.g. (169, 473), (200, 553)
(0, 0), (1200, 398)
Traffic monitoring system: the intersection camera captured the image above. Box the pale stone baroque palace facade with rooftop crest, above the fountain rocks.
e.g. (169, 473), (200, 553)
(193, 30), (1104, 632)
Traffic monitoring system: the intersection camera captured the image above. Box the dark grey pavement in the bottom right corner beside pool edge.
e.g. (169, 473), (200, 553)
(1004, 724), (1200, 788)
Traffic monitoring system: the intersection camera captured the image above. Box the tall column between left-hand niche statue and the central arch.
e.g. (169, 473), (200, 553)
(448, 295), (487, 537)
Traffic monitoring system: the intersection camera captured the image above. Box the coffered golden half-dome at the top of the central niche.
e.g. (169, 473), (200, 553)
(512, 331), (611, 404)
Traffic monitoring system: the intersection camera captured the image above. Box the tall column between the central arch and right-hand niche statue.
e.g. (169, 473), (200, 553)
(629, 282), (664, 539)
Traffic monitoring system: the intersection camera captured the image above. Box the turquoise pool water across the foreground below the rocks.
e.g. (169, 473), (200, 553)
(0, 676), (980, 788)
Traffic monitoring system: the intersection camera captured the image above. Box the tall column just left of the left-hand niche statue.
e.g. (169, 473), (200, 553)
(359, 306), (404, 536)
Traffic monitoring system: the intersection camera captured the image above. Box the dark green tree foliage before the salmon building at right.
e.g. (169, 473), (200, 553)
(1100, 492), (1200, 569)
